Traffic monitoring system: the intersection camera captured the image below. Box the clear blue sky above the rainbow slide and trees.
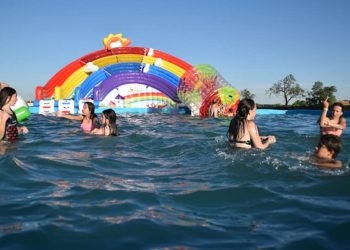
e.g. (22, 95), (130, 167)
(0, 0), (350, 103)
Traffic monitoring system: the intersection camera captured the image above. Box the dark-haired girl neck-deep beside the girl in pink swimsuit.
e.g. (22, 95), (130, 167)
(91, 109), (118, 136)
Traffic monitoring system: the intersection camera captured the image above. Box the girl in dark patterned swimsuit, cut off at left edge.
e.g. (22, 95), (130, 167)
(0, 87), (28, 141)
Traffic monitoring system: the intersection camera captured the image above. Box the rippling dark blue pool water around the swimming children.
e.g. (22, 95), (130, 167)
(0, 114), (350, 249)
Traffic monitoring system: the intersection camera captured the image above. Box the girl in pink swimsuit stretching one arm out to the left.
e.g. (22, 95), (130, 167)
(56, 102), (99, 133)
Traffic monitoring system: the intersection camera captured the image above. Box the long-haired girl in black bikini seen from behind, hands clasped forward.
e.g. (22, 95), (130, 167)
(227, 98), (276, 149)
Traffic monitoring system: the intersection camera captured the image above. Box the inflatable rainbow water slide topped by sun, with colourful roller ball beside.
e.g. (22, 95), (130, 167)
(13, 33), (240, 120)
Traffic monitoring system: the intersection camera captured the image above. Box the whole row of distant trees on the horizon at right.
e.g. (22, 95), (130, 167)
(241, 74), (337, 107)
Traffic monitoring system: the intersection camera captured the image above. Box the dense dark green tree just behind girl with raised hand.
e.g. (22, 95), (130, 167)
(306, 81), (337, 105)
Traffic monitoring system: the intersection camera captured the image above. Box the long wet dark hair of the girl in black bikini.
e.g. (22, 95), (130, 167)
(226, 98), (255, 143)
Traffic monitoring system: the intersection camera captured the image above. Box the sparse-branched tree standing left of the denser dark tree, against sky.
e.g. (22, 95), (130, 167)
(266, 74), (305, 107)
